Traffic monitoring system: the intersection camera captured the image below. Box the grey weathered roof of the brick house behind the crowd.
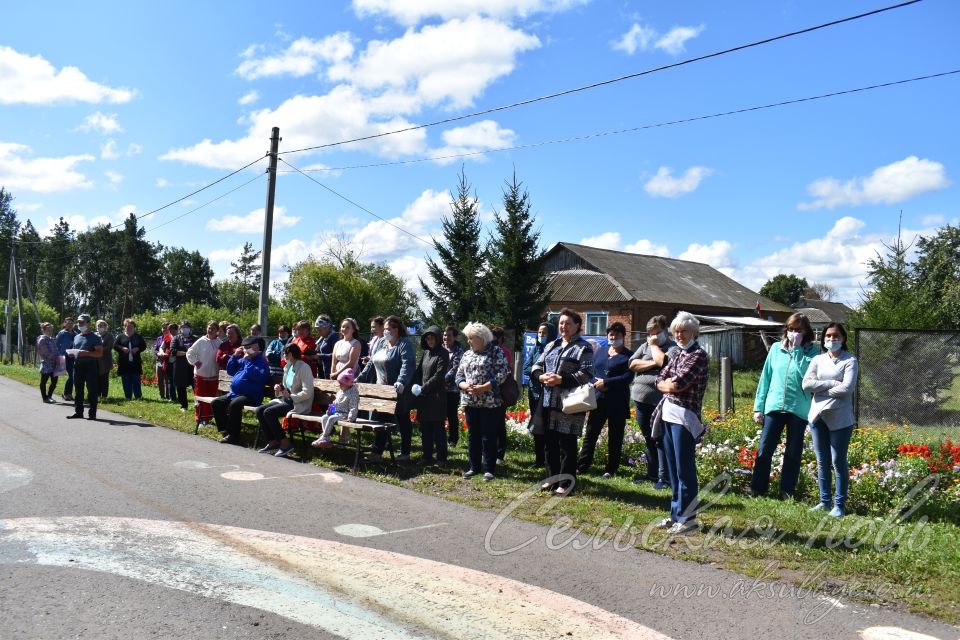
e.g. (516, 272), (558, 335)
(545, 242), (792, 312)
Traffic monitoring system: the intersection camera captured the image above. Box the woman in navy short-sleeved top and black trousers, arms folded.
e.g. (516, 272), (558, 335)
(577, 322), (633, 480)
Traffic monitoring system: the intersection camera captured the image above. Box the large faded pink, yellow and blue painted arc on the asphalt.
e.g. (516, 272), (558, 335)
(0, 517), (667, 640)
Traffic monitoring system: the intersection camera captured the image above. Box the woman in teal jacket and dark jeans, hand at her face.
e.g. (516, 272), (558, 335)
(749, 313), (817, 498)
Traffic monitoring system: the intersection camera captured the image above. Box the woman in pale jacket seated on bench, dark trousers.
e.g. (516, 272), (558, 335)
(256, 343), (313, 458)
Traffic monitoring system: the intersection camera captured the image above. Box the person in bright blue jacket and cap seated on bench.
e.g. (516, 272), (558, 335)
(211, 336), (270, 446)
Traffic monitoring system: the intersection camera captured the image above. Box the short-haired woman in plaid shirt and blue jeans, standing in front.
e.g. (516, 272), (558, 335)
(652, 311), (710, 535)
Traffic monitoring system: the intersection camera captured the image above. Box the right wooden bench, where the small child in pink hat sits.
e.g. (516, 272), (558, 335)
(288, 378), (397, 473)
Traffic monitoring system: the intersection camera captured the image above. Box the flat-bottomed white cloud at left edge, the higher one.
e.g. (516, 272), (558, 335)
(0, 46), (136, 105)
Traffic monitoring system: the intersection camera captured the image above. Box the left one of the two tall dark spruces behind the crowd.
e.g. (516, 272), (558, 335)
(420, 167), (489, 325)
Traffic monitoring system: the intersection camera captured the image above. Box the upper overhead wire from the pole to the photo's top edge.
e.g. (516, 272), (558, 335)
(280, 0), (922, 155)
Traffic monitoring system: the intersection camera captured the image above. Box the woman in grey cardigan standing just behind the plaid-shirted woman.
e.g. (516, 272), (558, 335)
(630, 316), (678, 489)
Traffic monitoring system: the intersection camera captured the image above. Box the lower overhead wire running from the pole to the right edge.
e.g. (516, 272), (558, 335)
(274, 69), (960, 173)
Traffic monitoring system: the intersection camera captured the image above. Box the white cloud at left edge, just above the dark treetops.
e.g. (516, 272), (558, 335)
(0, 142), (95, 193)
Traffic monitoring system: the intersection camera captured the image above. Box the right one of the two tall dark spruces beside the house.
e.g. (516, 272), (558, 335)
(487, 172), (549, 348)
